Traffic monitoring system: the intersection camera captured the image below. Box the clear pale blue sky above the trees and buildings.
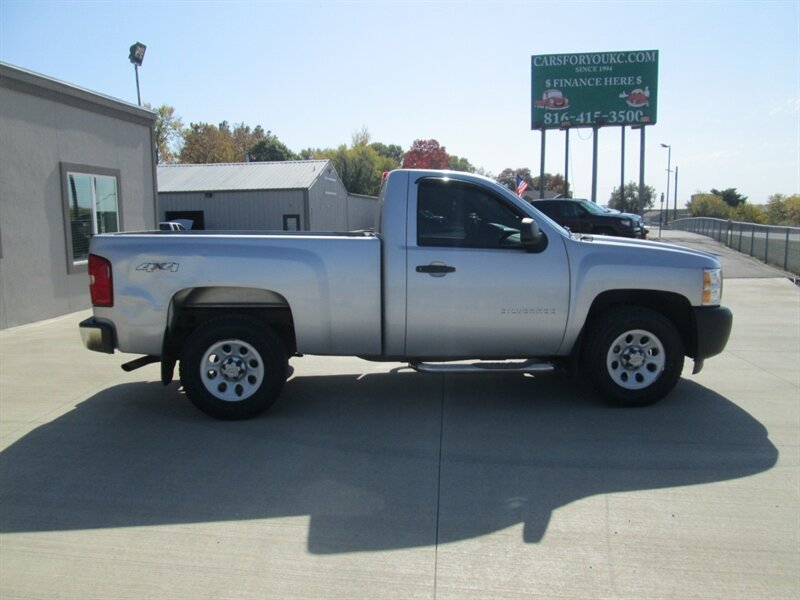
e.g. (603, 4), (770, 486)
(0, 0), (800, 207)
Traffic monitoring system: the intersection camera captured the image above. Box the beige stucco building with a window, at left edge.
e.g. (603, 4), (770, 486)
(0, 63), (157, 329)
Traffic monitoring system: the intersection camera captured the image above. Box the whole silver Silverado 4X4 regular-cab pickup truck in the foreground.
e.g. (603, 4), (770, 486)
(80, 170), (732, 419)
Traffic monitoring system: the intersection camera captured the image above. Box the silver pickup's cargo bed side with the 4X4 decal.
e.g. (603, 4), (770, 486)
(91, 231), (381, 356)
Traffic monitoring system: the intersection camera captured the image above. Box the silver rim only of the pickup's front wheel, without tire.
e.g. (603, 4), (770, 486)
(606, 329), (667, 390)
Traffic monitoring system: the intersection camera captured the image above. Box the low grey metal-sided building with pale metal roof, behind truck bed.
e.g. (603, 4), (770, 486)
(158, 160), (377, 231)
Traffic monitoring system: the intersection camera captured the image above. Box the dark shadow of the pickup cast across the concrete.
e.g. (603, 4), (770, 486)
(0, 372), (778, 554)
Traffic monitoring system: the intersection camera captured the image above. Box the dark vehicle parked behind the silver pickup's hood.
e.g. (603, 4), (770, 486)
(533, 198), (644, 238)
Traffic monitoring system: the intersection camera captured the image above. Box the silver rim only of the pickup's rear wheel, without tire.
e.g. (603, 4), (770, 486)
(200, 339), (264, 402)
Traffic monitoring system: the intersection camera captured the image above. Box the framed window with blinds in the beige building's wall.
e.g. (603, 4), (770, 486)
(61, 163), (122, 273)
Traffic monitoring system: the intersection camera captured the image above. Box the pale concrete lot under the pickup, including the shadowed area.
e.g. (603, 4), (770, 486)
(0, 232), (800, 600)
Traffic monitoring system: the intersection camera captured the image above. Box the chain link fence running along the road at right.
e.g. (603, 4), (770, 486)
(669, 217), (800, 275)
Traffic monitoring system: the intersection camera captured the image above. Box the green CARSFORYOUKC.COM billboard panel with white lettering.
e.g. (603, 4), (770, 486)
(531, 50), (658, 129)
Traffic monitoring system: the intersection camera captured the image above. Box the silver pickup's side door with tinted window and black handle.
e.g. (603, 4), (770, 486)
(406, 178), (569, 358)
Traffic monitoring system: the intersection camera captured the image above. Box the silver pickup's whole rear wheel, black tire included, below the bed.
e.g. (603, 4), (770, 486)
(180, 316), (288, 420)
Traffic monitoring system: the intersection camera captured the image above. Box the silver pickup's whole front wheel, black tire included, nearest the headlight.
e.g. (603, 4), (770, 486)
(582, 306), (684, 406)
